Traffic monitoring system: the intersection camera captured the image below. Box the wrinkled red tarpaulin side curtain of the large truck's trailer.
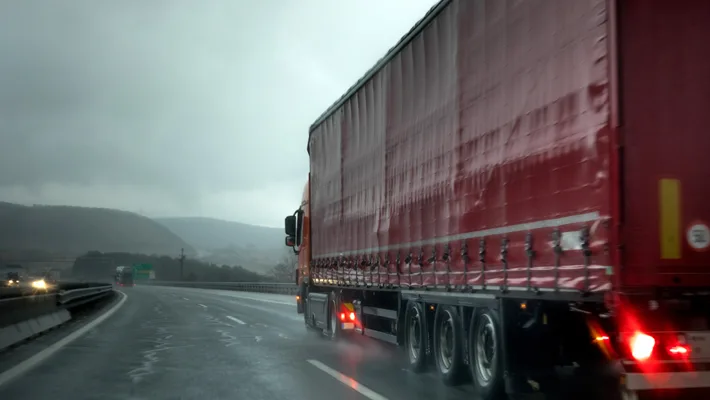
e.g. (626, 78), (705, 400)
(309, 0), (613, 291)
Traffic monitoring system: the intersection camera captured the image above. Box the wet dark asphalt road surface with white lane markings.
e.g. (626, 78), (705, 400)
(0, 286), (484, 400)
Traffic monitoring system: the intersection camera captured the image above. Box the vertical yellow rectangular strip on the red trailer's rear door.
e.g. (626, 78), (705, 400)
(658, 179), (682, 260)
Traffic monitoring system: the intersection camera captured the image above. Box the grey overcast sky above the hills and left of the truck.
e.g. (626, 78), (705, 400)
(0, 0), (436, 226)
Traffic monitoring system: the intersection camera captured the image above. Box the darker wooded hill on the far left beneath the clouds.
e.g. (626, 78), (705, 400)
(0, 202), (196, 256)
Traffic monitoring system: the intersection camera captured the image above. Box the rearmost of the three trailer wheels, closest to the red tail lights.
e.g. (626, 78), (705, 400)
(468, 309), (503, 400)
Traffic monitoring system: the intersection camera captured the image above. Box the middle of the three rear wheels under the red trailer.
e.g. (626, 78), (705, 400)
(434, 306), (466, 386)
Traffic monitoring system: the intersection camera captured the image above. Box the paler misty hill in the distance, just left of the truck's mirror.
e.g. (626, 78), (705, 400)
(155, 217), (285, 273)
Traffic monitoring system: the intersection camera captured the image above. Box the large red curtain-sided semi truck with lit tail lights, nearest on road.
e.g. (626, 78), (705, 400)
(285, 0), (710, 400)
